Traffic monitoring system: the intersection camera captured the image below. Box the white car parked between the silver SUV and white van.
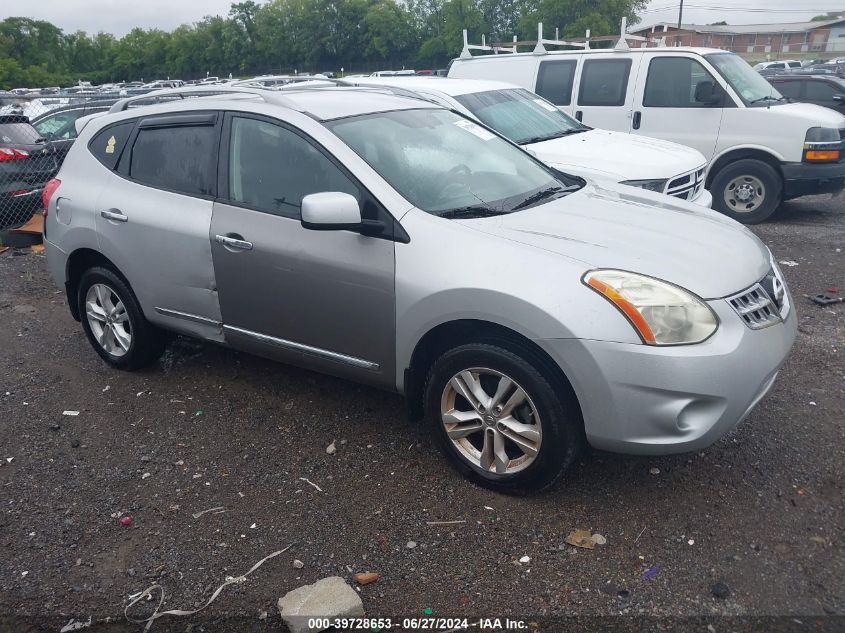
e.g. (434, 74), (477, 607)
(355, 77), (713, 208)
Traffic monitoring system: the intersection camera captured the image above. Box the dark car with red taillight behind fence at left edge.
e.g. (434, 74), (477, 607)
(0, 114), (59, 230)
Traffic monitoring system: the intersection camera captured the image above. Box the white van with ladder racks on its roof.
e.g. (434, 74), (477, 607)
(449, 42), (845, 224)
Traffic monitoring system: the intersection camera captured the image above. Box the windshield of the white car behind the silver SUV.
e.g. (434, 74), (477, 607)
(455, 89), (589, 145)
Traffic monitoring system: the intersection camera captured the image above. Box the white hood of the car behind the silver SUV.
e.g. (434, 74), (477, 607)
(524, 130), (707, 182)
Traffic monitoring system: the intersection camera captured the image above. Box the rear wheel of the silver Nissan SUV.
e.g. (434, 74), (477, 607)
(77, 267), (167, 371)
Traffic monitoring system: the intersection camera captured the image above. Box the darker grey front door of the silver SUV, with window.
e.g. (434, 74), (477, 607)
(210, 114), (395, 387)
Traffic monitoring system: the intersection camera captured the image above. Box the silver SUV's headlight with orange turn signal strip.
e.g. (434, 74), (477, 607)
(582, 270), (719, 345)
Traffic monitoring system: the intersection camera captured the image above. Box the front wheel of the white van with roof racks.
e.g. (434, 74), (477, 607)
(710, 159), (783, 224)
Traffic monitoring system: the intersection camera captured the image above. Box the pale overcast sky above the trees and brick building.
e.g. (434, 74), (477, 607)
(0, 0), (845, 36)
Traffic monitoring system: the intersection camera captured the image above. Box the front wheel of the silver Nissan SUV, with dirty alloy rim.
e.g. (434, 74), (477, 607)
(423, 343), (585, 493)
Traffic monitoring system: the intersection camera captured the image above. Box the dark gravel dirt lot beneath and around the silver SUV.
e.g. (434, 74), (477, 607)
(0, 197), (845, 631)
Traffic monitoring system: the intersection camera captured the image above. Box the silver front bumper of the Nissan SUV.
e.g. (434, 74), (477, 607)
(538, 298), (797, 455)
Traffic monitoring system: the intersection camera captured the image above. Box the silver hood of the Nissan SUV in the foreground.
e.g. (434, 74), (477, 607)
(461, 183), (771, 299)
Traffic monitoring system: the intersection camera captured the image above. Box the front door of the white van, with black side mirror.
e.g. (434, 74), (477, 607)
(631, 53), (734, 160)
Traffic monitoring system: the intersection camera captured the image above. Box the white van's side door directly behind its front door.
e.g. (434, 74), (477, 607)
(572, 53), (640, 132)
